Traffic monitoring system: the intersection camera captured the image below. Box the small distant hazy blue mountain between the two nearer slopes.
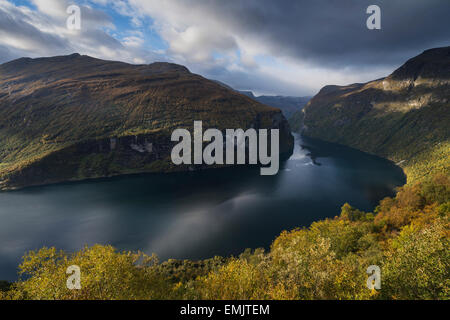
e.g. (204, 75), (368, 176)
(240, 91), (311, 119)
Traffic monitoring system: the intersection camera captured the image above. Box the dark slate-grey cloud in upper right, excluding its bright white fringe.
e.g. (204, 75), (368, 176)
(199, 0), (450, 67)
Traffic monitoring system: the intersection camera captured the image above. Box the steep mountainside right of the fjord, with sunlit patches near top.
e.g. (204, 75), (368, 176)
(291, 47), (450, 182)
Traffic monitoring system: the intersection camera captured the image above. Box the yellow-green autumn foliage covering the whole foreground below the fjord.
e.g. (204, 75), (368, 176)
(0, 175), (450, 299)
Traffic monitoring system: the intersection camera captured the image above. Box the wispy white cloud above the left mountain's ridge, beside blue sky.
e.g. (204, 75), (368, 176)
(0, 0), (162, 63)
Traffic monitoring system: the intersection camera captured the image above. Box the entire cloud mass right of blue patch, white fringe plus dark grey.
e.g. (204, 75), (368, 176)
(131, 0), (450, 95)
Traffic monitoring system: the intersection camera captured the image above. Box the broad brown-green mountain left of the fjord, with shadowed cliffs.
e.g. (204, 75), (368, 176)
(0, 54), (293, 189)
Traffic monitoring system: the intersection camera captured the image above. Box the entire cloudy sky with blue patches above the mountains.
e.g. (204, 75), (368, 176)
(0, 0), (450, 96)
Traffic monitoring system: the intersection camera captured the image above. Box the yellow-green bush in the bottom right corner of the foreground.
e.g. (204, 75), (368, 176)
(382, 219), (450, 300)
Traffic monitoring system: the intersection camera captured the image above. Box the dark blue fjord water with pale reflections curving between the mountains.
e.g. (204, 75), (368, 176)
(0, 137), (405, 280)
